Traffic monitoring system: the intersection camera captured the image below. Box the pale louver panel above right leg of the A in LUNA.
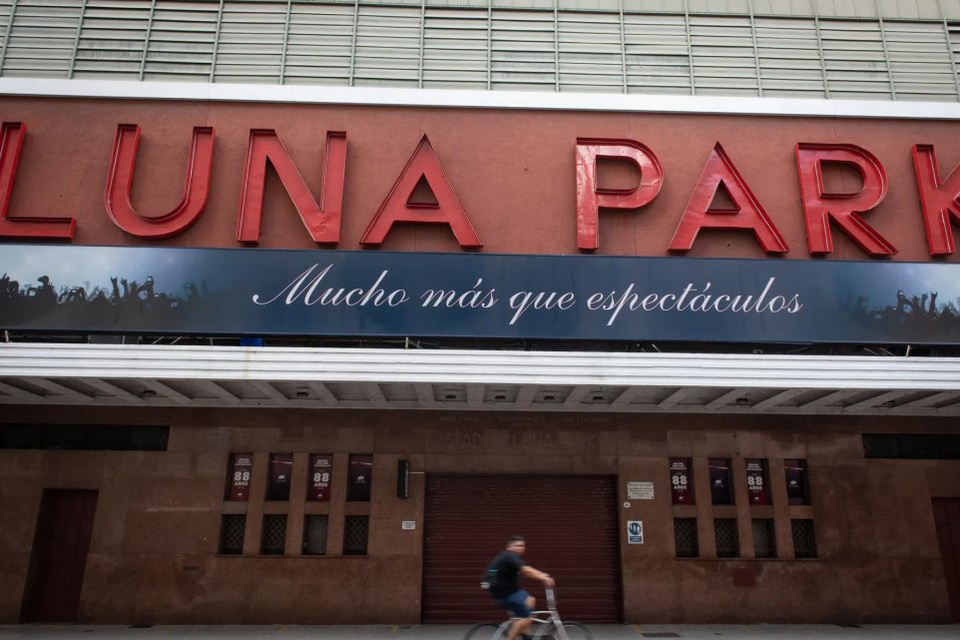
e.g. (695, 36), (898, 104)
(423, 9), (490, 89)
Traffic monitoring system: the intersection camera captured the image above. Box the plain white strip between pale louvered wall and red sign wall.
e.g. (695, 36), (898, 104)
(0, 78), (960, 120)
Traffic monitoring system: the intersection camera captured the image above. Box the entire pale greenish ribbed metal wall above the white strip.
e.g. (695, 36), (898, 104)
(0, 0), (960, 101)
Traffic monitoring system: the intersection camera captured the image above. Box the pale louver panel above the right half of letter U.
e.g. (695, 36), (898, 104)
(144, 0), (219, 82)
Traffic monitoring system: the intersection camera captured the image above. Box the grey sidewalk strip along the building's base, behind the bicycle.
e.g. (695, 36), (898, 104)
(0, 624), (960, 640)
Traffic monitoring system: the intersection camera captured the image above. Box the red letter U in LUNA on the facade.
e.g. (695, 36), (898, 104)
(104, 124), (213, 238)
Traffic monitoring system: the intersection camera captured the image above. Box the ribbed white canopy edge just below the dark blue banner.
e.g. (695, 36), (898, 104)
(0, 343), (960, 391)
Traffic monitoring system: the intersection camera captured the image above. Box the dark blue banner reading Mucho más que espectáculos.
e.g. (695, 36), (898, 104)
(0, 245), (960, 344)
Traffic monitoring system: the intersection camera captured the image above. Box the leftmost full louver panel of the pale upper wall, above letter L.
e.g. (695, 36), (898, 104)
(3, 0), (82, 78)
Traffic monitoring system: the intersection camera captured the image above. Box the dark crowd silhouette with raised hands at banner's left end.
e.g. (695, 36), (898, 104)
(0, 274), (211, 329)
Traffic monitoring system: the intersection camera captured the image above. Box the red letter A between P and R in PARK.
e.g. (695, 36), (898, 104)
(670, 142), (790, 253)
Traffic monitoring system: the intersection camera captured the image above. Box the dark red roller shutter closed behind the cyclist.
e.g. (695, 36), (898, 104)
(423, 475), (622, 623)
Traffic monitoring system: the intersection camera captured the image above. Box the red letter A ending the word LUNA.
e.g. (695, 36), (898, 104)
(360, 136), (483, 248)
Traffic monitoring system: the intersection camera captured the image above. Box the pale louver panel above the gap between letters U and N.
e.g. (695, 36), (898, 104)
(214, 1), (288, 83)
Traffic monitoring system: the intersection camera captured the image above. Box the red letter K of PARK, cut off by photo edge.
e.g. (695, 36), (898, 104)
(913, 144), (960, 256)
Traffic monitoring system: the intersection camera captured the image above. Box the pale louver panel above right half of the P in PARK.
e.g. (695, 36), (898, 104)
(623, 14), (691, 94)
